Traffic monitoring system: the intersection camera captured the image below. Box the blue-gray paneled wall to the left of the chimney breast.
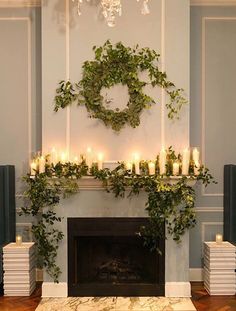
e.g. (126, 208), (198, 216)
(0, 8), (42, 239)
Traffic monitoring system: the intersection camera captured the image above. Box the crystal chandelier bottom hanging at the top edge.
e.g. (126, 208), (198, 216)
(72, 0), (150, 27)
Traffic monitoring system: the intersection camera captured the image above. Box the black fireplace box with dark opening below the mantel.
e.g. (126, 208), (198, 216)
(68, 217), (165, 296)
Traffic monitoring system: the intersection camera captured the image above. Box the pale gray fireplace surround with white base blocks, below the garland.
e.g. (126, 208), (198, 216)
(42, 180), (191, 297)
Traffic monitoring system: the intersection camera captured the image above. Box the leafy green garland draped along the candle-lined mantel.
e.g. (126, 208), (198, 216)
(21, 148), (214, 282)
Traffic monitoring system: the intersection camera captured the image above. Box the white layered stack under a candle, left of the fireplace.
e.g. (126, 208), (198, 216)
(3, 243), (36, 296)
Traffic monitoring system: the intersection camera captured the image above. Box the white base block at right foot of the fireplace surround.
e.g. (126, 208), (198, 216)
(165, 282), (191, 297)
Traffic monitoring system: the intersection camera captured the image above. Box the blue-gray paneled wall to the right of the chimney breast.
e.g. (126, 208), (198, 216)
(190, 6), (236, 268)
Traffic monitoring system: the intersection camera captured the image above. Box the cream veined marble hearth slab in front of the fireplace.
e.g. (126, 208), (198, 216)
(36, 297), (196, 311)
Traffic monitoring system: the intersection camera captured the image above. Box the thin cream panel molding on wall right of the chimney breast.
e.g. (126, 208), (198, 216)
(201, 16), (236, 197)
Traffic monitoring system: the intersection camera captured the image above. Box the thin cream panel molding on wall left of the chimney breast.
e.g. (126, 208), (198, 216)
(0, 17), (32, 165)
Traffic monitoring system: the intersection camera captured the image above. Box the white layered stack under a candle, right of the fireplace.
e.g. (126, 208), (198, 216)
(204, 242), (236, 295)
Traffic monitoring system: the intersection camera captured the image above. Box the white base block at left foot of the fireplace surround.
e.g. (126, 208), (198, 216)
(42, 282), (68, 297)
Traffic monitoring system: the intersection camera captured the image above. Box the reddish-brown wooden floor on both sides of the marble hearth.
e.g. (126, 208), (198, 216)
(0, 282), (236, 311)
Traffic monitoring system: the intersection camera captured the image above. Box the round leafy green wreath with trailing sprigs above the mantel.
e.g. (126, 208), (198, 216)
(54, 41), (187, 132)
